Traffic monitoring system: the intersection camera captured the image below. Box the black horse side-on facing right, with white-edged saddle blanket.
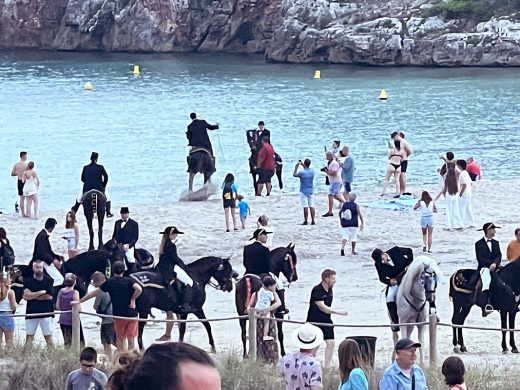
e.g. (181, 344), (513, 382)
(130, 257), (237, 352)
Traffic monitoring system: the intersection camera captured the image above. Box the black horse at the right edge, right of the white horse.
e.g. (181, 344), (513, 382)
(450, 261), (520, 353)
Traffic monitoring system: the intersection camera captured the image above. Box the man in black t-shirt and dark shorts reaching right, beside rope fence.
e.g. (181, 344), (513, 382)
(307, 269), (348, 367)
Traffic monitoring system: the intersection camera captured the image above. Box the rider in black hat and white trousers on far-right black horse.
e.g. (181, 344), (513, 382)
(475, 222), (502, 317)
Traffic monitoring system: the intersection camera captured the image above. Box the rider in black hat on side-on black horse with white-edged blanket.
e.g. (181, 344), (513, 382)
(156, 226), (193, 313)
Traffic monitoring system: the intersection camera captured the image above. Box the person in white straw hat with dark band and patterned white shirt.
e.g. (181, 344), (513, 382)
(281, 323), (323, 390)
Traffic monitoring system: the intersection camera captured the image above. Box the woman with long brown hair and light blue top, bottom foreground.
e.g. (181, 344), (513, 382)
(338, 339), (368, 390)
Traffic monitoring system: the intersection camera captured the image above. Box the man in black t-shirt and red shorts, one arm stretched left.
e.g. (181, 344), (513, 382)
(72, 261), (143, 351)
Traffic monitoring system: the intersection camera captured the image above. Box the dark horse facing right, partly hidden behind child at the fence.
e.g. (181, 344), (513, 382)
(235, 244), (298, 358)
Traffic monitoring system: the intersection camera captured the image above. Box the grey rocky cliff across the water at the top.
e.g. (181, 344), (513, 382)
(0, 0), (520, 66)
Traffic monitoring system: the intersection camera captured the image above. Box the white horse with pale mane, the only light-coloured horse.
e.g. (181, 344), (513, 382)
(396, 255), (442, 364)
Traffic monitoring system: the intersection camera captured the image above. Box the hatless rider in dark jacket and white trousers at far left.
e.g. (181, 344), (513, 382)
(32, 218), (64, 287)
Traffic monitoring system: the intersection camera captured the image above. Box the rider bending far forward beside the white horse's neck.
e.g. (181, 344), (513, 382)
(372, 246), (413, 332)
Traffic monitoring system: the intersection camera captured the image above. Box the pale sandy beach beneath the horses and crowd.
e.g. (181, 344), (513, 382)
(0, 179), (520, 365)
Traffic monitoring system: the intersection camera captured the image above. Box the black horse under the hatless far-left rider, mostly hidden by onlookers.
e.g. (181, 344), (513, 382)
(11, 240), (125, 302)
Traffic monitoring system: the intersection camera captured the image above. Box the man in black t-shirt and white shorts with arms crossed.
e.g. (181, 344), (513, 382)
(23, 260), (54, 347)
